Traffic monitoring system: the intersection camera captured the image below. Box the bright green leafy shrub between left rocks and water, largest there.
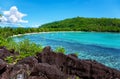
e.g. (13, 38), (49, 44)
(6, 39), (43, 55)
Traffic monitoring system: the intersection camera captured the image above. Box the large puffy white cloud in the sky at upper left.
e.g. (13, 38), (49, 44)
(0, 6), (28, 24)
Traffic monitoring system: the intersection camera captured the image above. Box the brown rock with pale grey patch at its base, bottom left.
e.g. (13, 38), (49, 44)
(0, 57), (38, 79)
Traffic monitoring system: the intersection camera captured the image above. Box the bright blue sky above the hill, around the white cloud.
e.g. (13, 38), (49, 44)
(0, 0), (120, 27)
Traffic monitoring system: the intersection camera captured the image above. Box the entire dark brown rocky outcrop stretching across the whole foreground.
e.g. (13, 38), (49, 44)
(0, 46), (120, 79)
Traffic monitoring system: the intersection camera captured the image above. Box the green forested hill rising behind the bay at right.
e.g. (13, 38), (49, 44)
(40, 17), (120, 32)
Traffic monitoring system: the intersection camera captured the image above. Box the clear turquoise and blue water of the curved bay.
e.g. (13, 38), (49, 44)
(14, 32), (120, 70)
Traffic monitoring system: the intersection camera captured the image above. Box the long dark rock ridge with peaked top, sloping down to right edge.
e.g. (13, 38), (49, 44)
(37, 47), (120, 79)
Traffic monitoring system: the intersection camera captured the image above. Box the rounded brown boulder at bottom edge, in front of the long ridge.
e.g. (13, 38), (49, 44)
(30, 63), (67, 79)
